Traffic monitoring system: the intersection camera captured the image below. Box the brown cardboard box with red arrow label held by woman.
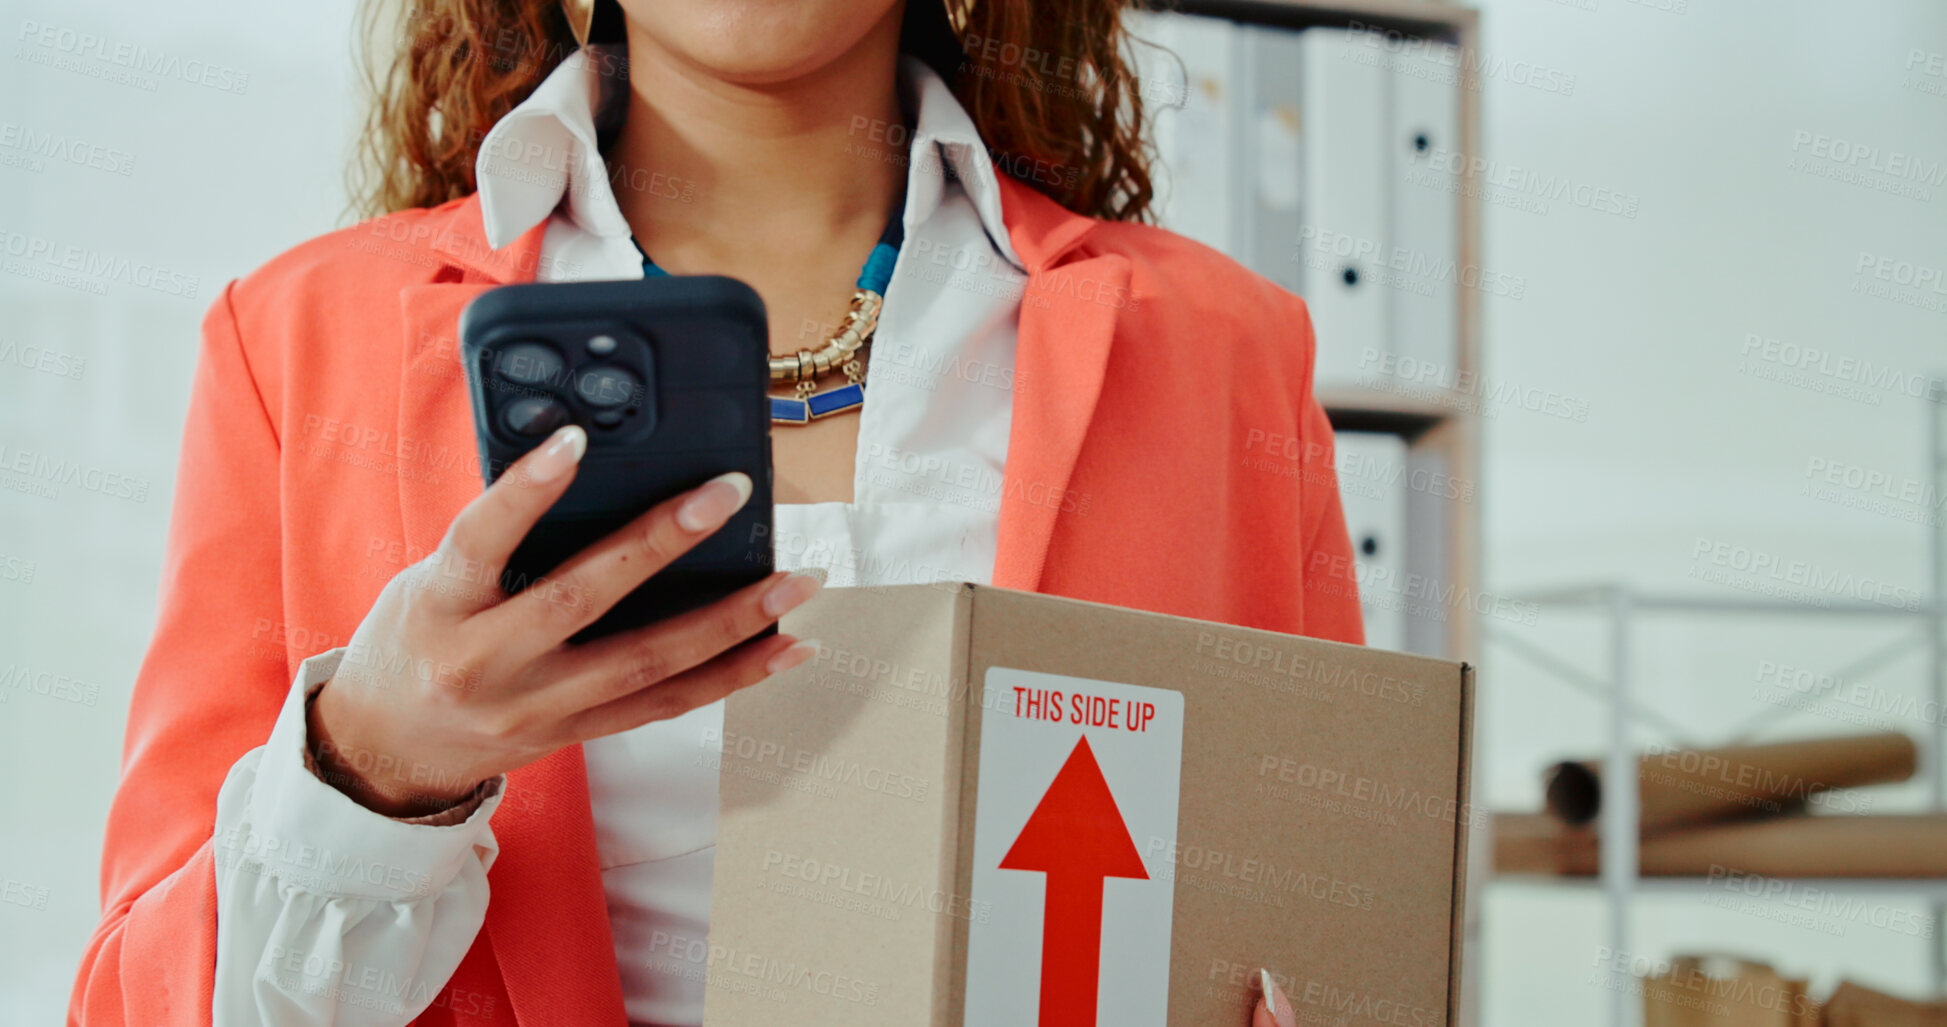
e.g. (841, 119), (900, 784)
(704, 585), (1480, 1027)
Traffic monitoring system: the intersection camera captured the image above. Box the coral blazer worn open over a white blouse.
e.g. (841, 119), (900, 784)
(68, 177), (1363, 1027)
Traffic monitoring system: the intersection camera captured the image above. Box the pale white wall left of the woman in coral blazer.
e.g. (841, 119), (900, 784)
(0, 0), (352, 1023)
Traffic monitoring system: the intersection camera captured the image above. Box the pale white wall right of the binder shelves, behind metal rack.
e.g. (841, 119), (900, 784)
(1478, 0), (1947, 1023)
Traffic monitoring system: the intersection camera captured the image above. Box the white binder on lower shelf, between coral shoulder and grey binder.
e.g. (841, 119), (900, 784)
(1336, 431), (1408, 651)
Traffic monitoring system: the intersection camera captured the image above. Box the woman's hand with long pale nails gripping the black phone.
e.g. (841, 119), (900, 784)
(310, 427), (818, 817)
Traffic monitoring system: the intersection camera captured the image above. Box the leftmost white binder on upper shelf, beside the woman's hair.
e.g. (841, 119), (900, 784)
(1125, 10), (1242, 253)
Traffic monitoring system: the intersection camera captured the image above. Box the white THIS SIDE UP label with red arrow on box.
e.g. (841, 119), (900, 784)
(966, 666), (1184, 1027)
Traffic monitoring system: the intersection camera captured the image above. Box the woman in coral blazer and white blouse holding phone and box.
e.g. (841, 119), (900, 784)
(70, 0), (1361, 1027)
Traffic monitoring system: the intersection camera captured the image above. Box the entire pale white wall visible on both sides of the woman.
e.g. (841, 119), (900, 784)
(0, 0), (1947, 1023)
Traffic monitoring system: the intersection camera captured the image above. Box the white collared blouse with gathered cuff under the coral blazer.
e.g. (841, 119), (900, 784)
(214, 44), (1026, 1027)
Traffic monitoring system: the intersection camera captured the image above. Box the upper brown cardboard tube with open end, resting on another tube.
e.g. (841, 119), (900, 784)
(1548, 731), (1920, 832)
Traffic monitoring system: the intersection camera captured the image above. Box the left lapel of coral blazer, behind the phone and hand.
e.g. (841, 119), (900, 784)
(397, 197), (627, 1023)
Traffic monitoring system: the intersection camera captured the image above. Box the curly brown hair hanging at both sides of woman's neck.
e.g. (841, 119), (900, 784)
(352, 0), (1153, 220)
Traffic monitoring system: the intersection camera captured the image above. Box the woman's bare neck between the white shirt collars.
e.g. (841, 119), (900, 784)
(607, 8), (905, 277)
